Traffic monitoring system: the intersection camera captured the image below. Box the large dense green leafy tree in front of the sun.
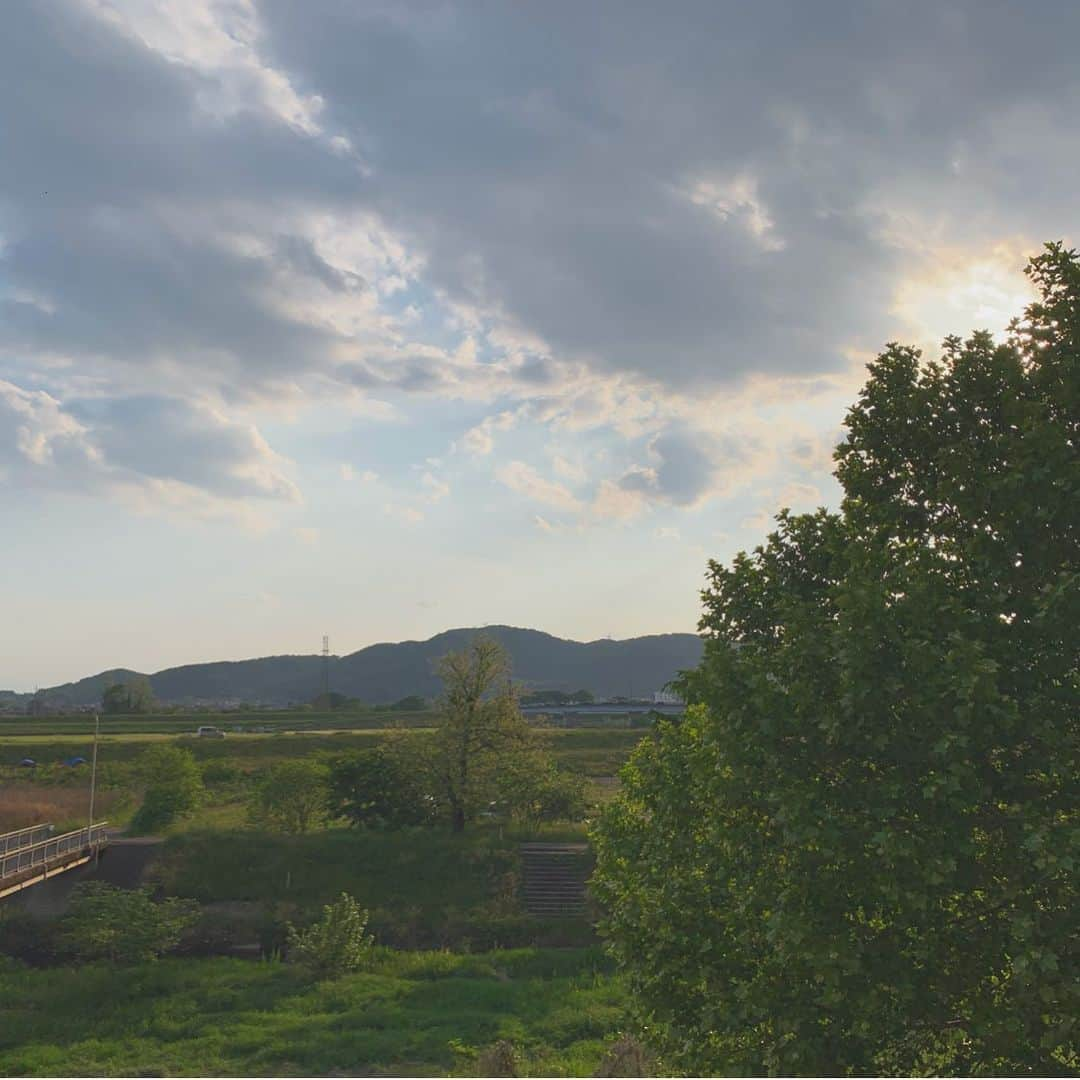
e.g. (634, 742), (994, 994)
(595, 245), (1080, 1075)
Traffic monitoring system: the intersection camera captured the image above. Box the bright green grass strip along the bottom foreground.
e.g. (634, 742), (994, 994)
(0, 949), (624, 1076)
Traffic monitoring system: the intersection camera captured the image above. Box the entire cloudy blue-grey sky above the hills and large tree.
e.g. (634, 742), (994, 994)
(0, 0), (1080, 690)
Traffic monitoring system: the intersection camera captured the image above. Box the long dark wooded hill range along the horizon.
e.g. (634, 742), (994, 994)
(8, 626), (701, 706)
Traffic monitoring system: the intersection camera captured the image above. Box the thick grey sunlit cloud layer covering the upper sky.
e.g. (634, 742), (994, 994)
(0, 0), (1080, 524)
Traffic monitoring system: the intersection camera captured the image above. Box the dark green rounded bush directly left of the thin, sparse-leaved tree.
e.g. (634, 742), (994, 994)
(329, 737), (435, 828)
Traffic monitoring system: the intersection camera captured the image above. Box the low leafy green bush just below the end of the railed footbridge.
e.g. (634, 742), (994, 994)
(58, 881), (199, 963)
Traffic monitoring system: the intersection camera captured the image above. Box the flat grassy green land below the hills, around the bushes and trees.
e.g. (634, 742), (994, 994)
(0, 714), (642, 1076)
